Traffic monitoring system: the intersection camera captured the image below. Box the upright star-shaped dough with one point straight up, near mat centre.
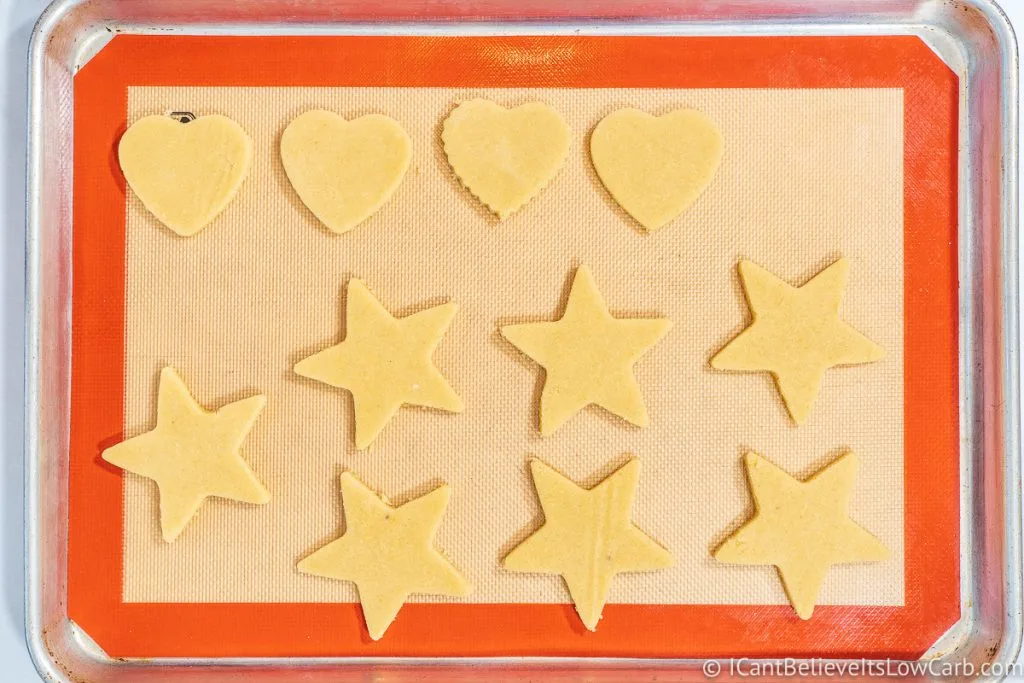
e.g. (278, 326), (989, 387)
(501, 265), (672, 436)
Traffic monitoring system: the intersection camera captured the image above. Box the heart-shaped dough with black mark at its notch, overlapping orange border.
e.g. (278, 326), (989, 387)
(118, 115), (253, 237)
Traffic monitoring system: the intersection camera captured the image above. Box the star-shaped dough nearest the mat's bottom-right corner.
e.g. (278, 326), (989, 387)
(715, 453), (889, 620)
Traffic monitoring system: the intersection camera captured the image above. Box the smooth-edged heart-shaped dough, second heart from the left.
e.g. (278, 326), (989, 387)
(281, 110), (413, 233)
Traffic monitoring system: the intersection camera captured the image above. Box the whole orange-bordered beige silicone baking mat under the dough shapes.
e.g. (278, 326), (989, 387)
(69, 36), (957, 656)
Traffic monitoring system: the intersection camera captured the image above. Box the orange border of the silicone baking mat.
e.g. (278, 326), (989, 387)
(68, 35), (959, 658)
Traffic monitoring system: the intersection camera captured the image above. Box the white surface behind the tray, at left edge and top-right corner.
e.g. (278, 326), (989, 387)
(0, 0), (1024, 683)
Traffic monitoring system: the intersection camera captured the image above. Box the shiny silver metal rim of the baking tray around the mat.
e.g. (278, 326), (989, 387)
(25, 0), (1022, 681)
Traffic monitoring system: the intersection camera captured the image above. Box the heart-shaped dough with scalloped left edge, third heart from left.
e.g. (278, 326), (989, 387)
(441, 99), (569, 218)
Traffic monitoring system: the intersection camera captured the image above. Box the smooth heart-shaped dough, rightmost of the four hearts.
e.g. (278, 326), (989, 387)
(590, 109), (723, 230)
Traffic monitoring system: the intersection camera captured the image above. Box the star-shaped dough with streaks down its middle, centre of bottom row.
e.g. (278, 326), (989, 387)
(503, 458), (673, 631)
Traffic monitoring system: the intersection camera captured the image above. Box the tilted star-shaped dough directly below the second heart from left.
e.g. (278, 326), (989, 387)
(295, 280), (463, 449)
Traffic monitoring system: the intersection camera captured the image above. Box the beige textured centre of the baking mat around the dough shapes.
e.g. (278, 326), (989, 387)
(123, 82), (904, 605)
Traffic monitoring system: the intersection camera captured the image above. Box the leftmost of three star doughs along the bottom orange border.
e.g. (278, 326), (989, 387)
(298, 472), (469, 640)
